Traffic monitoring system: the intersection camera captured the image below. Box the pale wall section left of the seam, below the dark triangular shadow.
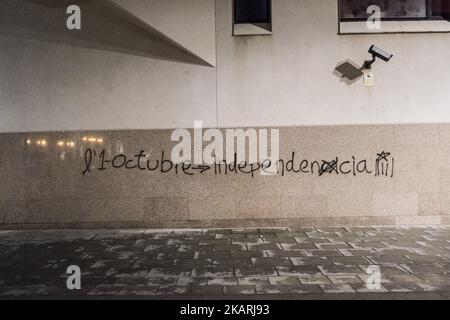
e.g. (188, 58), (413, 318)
(0, 0), (217, 132)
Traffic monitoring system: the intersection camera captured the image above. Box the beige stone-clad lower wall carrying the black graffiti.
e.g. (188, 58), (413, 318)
(0, 124), (450, 229)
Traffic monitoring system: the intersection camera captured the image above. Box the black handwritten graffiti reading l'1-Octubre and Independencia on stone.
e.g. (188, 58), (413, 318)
(83, 149), (395, 178)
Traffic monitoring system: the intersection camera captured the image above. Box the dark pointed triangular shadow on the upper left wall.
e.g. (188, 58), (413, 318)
(0, 0), (211, 66)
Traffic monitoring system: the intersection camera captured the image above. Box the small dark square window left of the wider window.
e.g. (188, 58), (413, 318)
(234, 0), (272, 23)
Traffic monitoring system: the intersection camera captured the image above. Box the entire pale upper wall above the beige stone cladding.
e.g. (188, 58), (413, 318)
(0, 0), (450, 132)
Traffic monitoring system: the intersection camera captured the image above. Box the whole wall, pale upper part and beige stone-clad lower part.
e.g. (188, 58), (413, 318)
(0, 0), (450, 228)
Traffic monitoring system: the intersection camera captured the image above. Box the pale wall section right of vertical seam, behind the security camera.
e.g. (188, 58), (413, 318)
(216, 0), (450, 126)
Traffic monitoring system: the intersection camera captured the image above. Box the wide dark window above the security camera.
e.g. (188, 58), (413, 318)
(339, 0), (450, 22)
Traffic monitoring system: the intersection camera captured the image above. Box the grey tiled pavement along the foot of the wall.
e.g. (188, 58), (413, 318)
(0, 227), (450, 299)
